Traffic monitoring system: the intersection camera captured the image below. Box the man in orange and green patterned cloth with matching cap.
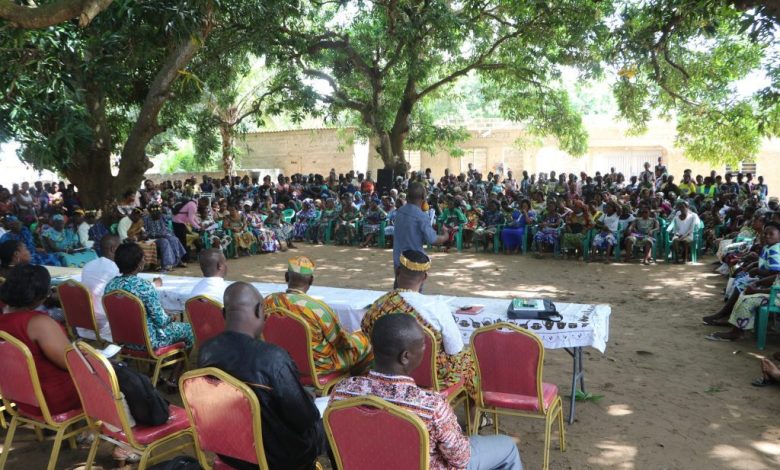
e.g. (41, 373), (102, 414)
(265, 256), (373, 374)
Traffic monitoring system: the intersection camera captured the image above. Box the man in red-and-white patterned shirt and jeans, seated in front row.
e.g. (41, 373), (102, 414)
(331, 313), (523, 470)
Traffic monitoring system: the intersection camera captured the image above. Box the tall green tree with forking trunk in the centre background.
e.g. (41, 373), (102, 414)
(277, 0), (611, 171)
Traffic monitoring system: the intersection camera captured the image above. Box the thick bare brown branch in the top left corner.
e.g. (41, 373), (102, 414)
(0, 0), (111, 29)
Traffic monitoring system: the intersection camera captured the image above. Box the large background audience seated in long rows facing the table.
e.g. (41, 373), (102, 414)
(0, 158), (778, 271)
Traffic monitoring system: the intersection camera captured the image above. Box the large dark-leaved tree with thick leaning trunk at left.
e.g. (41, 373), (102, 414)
(0, 0), (293, 207)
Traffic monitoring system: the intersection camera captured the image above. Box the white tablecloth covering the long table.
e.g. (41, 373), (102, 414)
(51, 269), (612, 353)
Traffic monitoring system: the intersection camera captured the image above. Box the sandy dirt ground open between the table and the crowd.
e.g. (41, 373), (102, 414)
(2, 245), (780, 470)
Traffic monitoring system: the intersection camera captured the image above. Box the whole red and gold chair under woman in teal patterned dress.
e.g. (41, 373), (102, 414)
(103, 290), (187, 386)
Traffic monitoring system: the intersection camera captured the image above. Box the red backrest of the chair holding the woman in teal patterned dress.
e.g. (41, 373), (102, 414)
(103, 290), (149, 347)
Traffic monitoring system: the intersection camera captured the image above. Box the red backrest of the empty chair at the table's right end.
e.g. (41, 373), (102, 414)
(471, 323), (544, 410)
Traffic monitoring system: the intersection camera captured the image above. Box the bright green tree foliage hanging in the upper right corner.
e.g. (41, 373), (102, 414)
(611, 0), (780, 166)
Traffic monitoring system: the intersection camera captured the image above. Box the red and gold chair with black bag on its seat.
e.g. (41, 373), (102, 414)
(65, 341), (194, 470)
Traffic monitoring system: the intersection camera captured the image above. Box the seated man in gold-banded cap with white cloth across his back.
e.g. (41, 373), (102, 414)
(360, 250), (476, 397)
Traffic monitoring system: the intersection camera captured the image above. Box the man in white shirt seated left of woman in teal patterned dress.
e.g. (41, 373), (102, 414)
(76, 235), (119, 341)
